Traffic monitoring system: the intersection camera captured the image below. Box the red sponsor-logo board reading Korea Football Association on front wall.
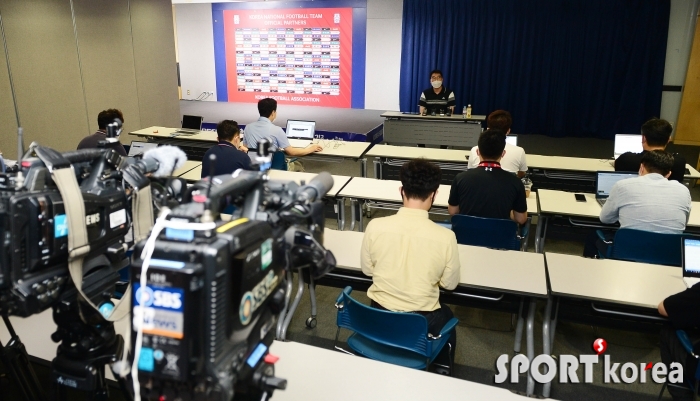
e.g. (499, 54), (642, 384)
(224, 8), (352, 107)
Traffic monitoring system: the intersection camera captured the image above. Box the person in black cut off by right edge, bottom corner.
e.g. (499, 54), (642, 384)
(659, 284), (700, 401)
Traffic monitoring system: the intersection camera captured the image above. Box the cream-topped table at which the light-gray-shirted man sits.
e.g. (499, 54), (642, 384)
(535, 189), (700, 253)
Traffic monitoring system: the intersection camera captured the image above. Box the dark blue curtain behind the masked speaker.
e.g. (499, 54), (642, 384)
(400, 0), (670, 139)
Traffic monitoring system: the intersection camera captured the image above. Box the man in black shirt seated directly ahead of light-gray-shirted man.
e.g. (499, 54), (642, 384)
(615, 118), (685, 183)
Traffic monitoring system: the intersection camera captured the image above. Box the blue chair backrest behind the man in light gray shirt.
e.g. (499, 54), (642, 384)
(610, 228), (683, 267)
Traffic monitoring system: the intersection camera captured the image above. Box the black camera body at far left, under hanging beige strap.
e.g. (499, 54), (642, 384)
(0, 149), (129, 317)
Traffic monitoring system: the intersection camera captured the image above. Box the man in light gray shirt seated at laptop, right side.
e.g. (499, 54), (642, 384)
(600, 150), (691, 234)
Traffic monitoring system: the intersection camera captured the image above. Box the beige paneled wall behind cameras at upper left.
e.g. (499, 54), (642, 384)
(0, 0), (180, 153)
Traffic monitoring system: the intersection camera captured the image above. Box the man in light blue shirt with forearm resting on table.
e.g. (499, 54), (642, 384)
(243, 98), (323, 157)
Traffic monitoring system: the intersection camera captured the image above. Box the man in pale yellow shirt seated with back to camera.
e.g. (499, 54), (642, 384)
(360, 159), (460, 366)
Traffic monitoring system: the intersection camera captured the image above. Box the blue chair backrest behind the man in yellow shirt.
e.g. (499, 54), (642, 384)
(336, 286), (432, 357)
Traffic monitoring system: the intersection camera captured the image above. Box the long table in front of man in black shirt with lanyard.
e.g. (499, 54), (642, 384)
(338, 177), (537, 231)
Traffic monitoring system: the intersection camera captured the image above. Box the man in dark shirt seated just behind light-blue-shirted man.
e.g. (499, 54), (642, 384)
(202, 120), (252, 178)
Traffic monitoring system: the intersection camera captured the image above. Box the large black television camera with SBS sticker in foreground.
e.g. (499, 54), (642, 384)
(131, 142), (335, 400)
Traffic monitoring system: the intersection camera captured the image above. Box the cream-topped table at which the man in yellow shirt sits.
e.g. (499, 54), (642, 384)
(324, 229), (549, 394)
